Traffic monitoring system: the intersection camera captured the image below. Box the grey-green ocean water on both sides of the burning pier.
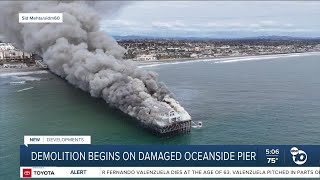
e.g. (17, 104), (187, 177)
(0, 55), (320, 179)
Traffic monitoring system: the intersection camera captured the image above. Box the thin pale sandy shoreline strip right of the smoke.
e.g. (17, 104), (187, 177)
(133, 51), (320, 66)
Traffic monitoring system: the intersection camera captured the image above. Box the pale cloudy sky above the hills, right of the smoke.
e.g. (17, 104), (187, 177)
(101, 1), (320, 38)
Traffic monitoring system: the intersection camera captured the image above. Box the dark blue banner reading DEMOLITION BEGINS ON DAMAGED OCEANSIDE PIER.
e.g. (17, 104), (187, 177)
(20, 145), (320, 167)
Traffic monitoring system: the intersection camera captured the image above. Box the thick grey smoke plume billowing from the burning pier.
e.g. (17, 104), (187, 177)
(0, 1), (191, 125)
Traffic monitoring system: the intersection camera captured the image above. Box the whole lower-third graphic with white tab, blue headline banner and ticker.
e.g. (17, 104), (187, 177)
(20, 136), (320, 178)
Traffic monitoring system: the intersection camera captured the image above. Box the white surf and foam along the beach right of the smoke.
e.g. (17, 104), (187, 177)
(137, 52), (320, 68)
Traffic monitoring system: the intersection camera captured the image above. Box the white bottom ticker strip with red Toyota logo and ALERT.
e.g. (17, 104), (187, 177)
(20, 167), (320, 179)
